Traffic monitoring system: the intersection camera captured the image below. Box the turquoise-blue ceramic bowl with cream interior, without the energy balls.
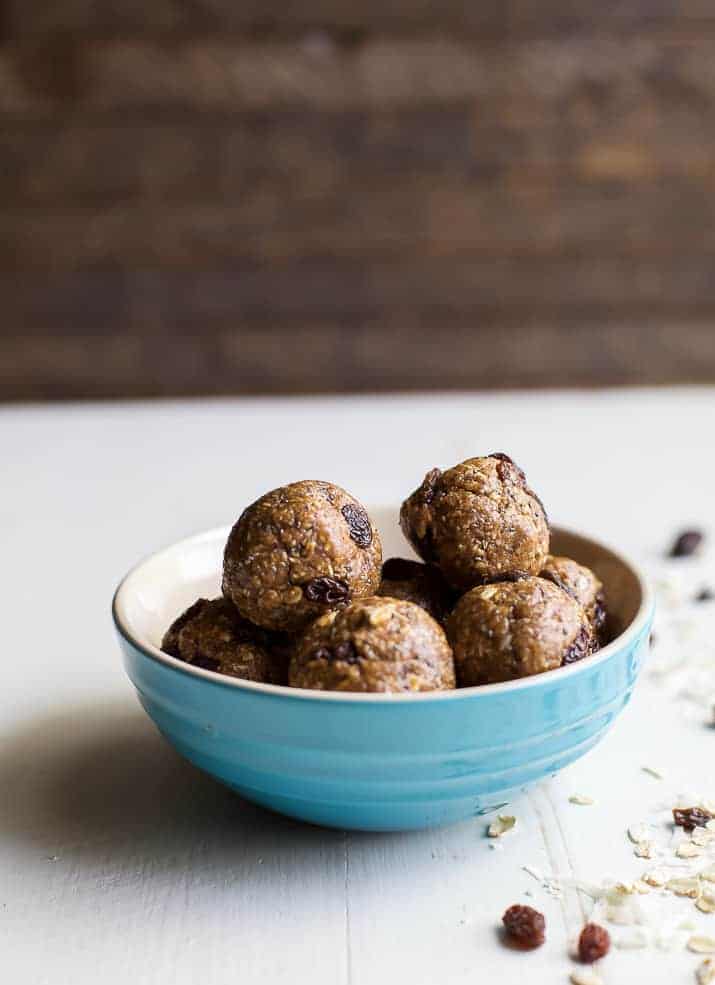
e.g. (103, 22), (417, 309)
(113, 521), (653, 831)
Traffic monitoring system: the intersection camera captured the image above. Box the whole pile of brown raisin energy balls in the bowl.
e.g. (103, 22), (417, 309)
(162, 453), (606, 693)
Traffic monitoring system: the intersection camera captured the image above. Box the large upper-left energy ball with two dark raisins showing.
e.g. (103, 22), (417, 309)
(223, 480), (382, 631)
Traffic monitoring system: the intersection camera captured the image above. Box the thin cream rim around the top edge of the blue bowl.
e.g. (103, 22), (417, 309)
(112, 524), (655, 704)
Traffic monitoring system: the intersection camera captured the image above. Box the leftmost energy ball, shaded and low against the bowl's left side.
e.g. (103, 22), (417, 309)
(161, 598), (289, 684)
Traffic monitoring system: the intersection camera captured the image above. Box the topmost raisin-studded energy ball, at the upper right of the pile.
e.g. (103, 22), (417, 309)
(400, 452), (549, 591)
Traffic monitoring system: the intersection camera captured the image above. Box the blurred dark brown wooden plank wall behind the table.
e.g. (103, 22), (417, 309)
(0, 0), (715, 399)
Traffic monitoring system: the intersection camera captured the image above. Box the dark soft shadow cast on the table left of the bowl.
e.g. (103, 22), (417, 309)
(0, 700), (344, 875)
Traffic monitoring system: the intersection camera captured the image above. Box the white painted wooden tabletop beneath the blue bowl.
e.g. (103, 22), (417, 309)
(0, 389), (715, 985)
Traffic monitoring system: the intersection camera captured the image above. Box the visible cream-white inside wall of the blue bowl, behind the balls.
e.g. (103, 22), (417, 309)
(117, 509), (643, 660)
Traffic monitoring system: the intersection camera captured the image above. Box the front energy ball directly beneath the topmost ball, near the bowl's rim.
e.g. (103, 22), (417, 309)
(447, 575), (594, 687)
